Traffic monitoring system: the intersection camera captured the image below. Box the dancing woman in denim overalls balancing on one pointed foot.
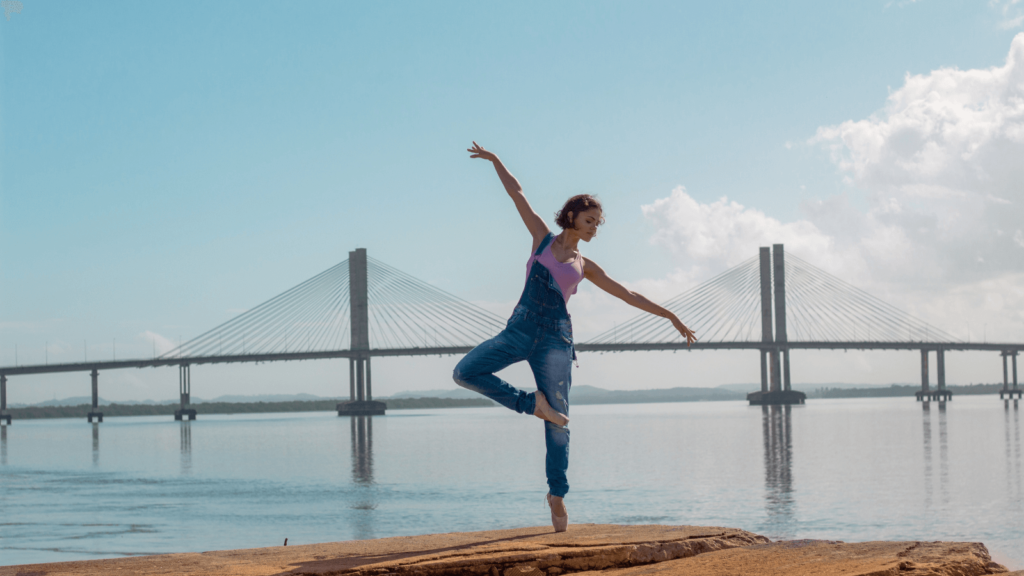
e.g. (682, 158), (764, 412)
(453, 141), (696, 532)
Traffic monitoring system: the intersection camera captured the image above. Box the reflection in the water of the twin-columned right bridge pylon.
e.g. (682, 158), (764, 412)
(761, 406), (796, 538)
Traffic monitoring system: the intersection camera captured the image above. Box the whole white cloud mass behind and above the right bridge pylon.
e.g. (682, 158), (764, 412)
(630, 34), (1024, 339)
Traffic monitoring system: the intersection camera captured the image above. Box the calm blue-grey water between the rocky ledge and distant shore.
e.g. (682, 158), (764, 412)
(0, 397), (1024, 568)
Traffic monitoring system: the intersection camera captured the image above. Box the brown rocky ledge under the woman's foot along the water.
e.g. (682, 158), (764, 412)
(0, 524), (1007, 576)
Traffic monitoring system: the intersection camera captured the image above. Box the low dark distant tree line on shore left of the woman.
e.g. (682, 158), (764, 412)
(7, 398), (495, 419)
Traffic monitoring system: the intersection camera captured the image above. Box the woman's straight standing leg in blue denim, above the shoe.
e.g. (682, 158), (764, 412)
(529, 340), (572, 498)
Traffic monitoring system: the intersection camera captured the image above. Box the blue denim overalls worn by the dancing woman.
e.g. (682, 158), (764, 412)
(453, 233), (575, 497)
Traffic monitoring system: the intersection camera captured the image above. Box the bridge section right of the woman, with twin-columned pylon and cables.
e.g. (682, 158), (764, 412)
(578, 244), (1024, 404)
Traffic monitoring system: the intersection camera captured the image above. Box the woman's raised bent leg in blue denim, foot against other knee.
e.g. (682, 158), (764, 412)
(452, 329), (537, 414)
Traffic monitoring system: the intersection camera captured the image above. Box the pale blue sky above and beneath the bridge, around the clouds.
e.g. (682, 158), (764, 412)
(0, 0), (1024, 402)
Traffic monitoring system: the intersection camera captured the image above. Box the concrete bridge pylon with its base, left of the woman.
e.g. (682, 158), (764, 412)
(337, 248), (387, 416)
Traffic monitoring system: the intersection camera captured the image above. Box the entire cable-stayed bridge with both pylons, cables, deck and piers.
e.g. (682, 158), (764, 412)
(0, 244), (1024, 422)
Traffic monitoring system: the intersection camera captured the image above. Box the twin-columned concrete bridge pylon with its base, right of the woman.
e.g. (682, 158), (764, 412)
(746, 244), (807, 406)
